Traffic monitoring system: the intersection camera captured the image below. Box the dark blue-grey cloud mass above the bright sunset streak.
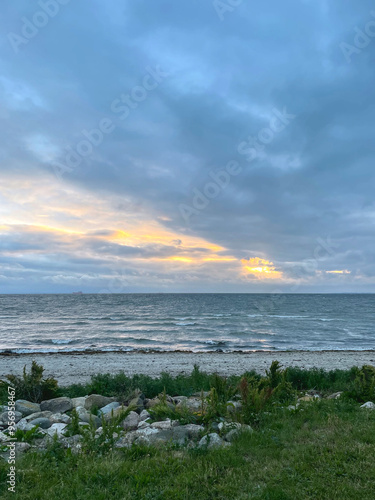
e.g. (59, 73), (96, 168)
(0, 0), (375, 292)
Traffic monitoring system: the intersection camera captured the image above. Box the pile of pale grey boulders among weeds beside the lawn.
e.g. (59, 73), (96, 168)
(0, 393), (252, 458)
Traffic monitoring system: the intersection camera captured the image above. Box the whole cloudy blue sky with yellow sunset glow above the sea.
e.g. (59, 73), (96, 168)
(0, 0), (375, 293)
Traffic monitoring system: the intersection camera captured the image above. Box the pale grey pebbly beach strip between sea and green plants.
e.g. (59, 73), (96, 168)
(0, 351), (375, 386)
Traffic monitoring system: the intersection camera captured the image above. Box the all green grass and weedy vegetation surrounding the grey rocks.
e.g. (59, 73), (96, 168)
(0, 362), (375, 500)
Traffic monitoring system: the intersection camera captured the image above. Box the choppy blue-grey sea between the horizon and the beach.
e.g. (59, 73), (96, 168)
(0, 294), (375, 353)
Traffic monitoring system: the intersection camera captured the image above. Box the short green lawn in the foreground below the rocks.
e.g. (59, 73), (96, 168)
(0, 400), (375, 500)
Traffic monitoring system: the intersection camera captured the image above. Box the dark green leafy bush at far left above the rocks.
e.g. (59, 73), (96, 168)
(2, 361), (59, 403)
